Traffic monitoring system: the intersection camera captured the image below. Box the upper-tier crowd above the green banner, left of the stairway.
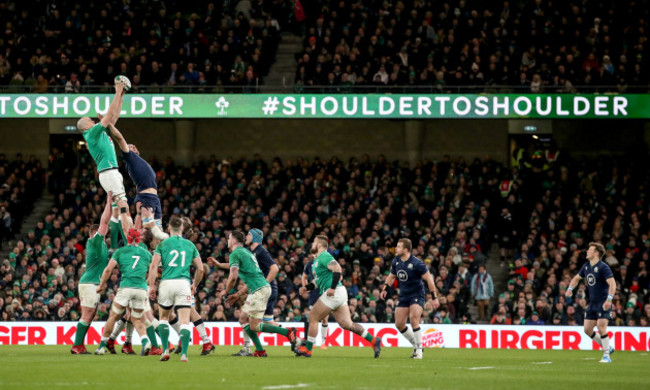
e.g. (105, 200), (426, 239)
(0, 0), (285, 93)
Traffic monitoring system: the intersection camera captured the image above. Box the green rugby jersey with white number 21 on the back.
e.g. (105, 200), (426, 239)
(154, 236), (200, 283)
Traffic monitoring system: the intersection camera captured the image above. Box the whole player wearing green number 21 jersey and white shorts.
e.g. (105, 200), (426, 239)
(149, 216), (203, 362)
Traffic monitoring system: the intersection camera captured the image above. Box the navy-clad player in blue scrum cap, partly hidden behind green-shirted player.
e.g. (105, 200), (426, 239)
(208, 229), (280, 356)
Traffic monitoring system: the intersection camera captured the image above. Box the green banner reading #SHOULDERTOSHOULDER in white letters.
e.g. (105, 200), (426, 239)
(0, 94), (650, 119)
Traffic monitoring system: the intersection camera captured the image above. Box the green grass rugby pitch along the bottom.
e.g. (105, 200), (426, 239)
(0, 346), (650, 390)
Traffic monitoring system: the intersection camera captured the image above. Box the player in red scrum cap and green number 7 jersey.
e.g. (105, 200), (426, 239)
(95, 229), (161, 355)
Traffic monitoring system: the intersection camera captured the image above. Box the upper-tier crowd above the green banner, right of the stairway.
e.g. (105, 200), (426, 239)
(295, 0), (650, 93)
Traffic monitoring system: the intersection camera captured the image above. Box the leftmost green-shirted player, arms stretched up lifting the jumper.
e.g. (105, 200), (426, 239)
(70, 192), (111, 355)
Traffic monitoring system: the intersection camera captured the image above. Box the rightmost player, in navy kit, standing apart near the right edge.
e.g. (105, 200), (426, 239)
(565, 242), (616, 363)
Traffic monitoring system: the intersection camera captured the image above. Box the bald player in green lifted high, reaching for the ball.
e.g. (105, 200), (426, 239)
(77, 81), (133, 232)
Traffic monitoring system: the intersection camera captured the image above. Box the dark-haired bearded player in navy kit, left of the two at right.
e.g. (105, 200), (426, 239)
(380, 238), (439, 359)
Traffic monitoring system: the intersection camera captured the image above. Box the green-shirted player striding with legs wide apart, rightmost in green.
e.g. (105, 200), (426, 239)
(295, 235), (381, 358)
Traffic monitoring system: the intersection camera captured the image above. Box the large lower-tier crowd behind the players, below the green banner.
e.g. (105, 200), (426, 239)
(0, 145), (650, 326)
